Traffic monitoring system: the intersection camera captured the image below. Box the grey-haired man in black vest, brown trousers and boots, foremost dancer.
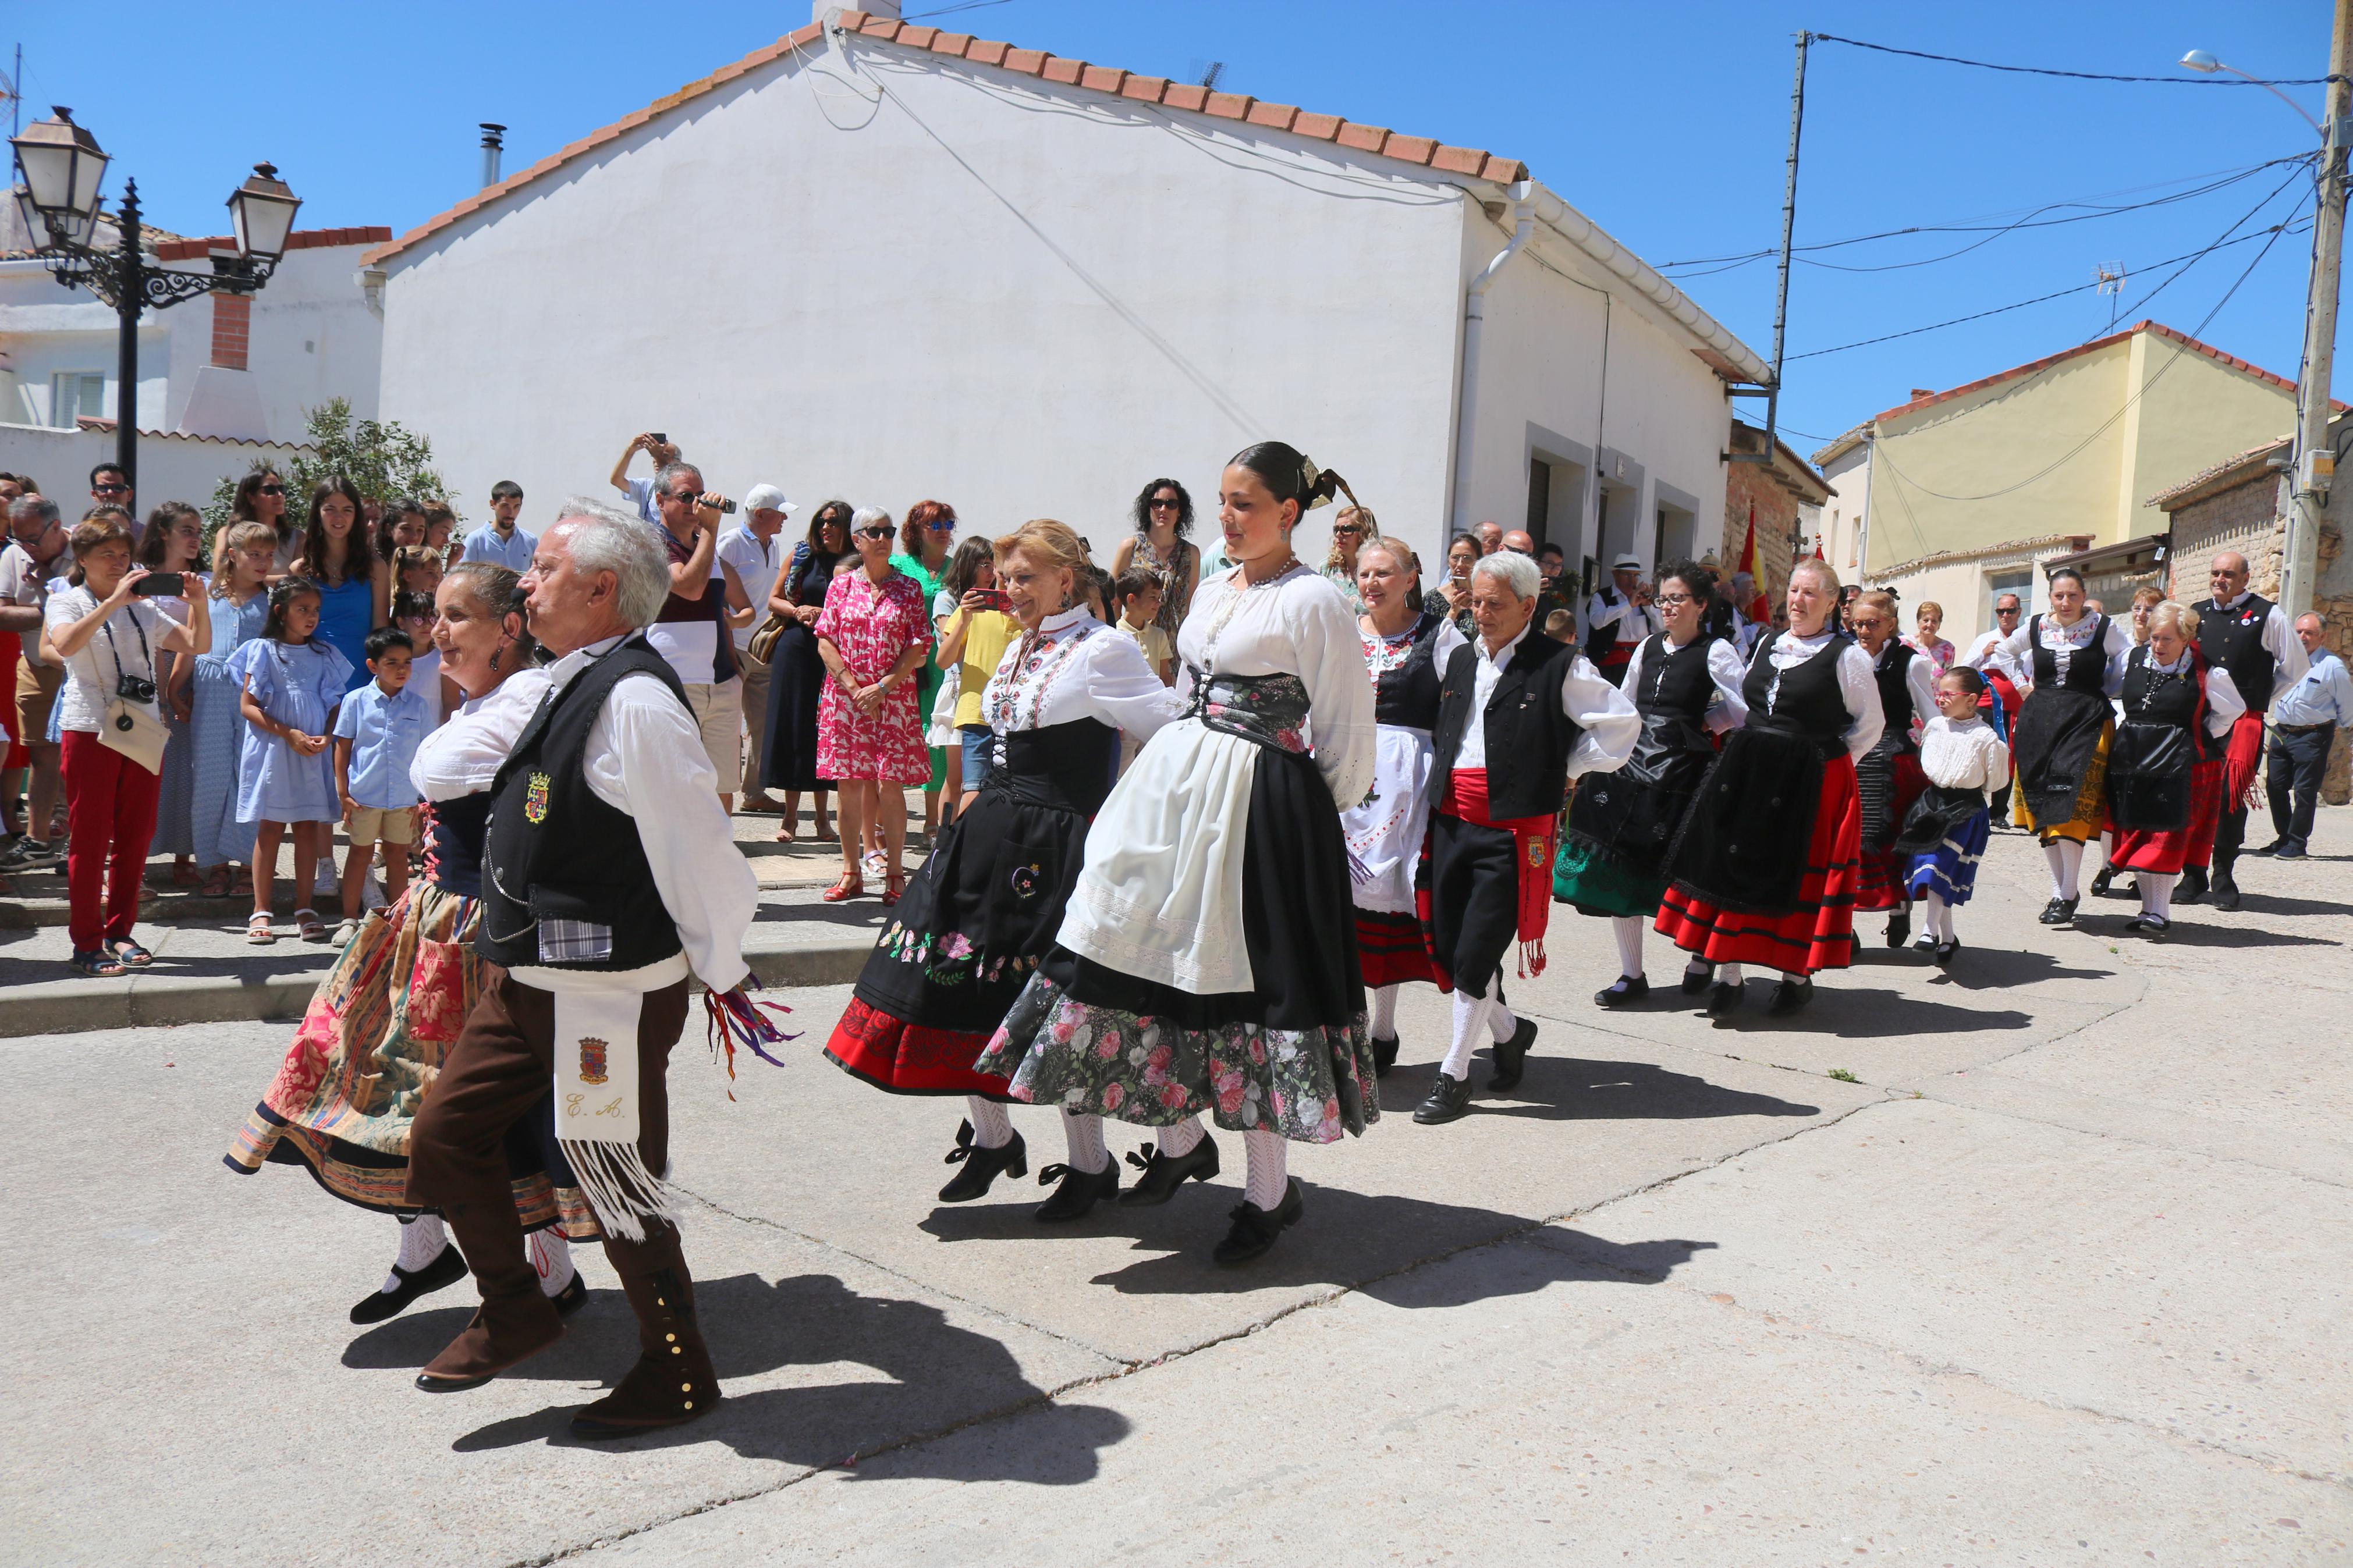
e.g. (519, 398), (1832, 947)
(409, 499), (760, 1437)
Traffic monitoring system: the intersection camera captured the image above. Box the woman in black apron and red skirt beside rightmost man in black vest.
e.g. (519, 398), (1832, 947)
(2109, 602), (2247, 936)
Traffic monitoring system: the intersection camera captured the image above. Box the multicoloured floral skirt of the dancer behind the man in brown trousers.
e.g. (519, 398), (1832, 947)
(223, 881), (602, 1241)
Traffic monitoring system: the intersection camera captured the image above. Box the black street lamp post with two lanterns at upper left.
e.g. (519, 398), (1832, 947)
(9, 108), (301, 489)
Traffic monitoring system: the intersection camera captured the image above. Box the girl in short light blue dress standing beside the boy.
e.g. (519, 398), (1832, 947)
(230, 576), (350, 945)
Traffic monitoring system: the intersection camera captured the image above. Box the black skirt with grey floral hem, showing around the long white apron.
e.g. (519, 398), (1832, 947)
(977, 748), (1381, 1143)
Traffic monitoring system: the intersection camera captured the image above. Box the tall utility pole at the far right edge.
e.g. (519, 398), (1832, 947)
(2280, 0), (2353, 621)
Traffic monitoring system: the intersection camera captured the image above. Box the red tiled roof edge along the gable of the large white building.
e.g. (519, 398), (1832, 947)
(360, 12), (1527, 266)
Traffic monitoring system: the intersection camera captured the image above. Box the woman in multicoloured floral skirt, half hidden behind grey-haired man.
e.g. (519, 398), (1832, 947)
(223, 562), (588, 1324)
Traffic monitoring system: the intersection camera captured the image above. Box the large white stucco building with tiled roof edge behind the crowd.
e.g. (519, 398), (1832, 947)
(367, 12), (1767, 583)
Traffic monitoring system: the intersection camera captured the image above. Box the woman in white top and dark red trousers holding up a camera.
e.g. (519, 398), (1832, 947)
(42, 513), (212, 976)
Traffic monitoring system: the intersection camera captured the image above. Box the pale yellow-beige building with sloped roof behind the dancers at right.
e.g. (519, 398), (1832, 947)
(1814, 322), (2297, 642)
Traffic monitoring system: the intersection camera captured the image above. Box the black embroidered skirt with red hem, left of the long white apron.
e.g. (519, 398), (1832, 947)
(826, 780), (1087, 1100)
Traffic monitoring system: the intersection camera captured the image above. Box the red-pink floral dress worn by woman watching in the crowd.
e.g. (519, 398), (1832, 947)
(814, 564), (932, 785)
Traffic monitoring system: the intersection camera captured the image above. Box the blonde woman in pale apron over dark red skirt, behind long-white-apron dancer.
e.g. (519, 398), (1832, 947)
(1339, 538), (1464, 1077)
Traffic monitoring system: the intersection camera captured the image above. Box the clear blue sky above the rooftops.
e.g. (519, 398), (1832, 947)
(13, 0), (2353, 451)
